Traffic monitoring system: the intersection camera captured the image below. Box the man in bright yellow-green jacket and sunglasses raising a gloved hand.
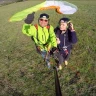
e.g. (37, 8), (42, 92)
(22, 12), (57, 68)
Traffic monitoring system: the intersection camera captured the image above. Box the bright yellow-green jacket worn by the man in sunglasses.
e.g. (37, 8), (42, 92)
(22, 24), (57, 51)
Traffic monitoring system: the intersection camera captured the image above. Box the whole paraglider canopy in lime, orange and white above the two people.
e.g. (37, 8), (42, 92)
(9, 0), (78, 22)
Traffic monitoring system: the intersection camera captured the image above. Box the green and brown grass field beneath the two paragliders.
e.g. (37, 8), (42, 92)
(0, 0), (96, 96)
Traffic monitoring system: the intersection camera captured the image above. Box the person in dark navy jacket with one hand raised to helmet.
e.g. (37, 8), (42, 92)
(55, 18), (77, 70)
